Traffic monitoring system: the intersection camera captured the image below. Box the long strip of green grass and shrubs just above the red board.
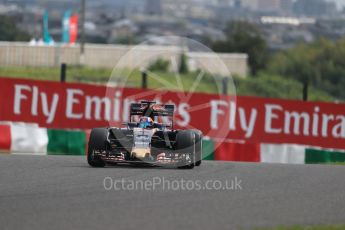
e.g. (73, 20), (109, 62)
(0, 66), (334, 101)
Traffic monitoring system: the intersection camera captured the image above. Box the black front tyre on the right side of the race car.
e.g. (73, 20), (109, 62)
(176, 130), (195, 169)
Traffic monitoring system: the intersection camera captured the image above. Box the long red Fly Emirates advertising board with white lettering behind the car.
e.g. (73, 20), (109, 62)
(0, 78), (345, 149)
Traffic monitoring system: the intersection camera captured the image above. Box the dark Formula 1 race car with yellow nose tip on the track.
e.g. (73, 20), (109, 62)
(87, 101), (203, 169)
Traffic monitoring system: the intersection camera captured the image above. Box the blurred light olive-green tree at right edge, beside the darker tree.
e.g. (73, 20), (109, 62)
(266, 39), (345, 100)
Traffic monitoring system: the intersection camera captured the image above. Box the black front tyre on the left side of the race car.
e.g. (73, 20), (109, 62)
(87, 128), (108, 168)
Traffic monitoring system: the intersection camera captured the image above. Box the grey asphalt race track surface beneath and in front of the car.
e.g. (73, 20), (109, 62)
(0, 155), (345, 230)
